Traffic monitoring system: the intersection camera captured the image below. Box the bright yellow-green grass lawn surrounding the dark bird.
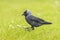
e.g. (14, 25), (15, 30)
(0, 0), (60, 40)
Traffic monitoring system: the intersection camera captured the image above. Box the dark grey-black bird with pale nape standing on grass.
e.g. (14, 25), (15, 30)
(23, 10), (52, 30)
